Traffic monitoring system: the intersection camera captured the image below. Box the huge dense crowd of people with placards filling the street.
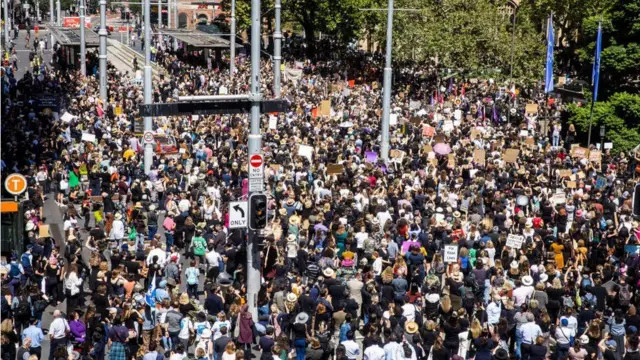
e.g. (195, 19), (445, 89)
(0, 19), (640, 360)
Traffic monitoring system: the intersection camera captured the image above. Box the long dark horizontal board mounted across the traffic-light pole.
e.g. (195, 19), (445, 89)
(138, 100), (289, 117)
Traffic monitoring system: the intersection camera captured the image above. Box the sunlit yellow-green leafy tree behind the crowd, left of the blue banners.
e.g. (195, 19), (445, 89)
(370, 0), (544, 79)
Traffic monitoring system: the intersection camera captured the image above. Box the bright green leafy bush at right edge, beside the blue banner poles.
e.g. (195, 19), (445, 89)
(568, 92), (640, 153)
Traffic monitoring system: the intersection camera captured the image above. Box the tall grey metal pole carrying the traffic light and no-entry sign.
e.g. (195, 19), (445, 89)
(247, 0), (262, 321)
